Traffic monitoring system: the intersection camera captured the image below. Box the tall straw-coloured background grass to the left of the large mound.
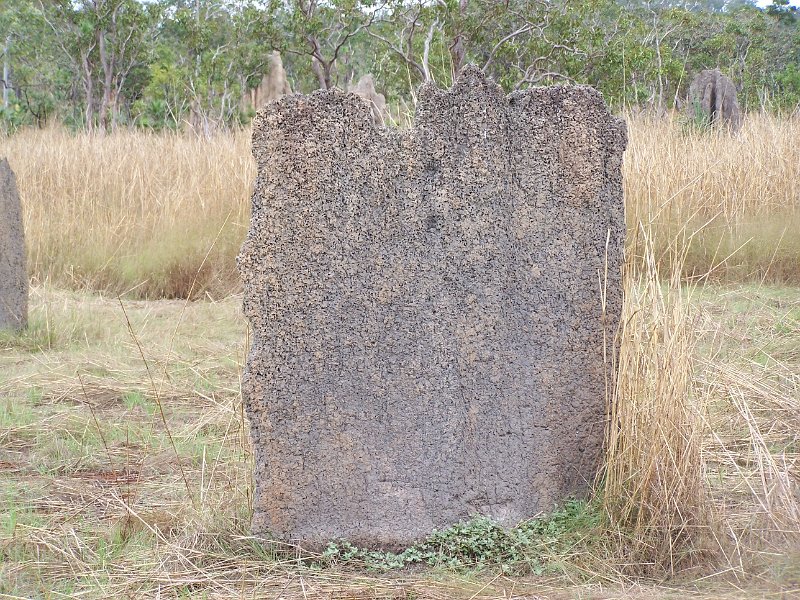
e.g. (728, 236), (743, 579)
(0, 129), (255, 298)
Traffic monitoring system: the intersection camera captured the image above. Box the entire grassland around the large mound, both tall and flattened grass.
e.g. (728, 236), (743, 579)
(0, 116), (800, 599)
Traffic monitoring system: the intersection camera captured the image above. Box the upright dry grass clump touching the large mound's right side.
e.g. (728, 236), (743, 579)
(602, 223), (710, 573)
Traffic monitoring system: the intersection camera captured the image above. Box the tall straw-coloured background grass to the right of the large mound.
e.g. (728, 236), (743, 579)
(624, 114), (800, 283)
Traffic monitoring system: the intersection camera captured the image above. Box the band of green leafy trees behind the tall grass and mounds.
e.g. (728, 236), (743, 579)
(0, 0), (800, 125)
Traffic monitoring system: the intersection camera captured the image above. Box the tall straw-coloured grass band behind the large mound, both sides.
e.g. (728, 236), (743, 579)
(0, 115), (800, 298)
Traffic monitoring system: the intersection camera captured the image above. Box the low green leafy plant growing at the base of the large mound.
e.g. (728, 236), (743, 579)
(318, 500), (601, 575)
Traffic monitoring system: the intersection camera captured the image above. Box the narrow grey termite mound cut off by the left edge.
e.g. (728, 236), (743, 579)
(0, 159), (28, 330)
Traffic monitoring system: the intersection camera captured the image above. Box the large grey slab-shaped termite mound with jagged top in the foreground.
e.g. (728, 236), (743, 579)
(239, 68), (626, 547)
